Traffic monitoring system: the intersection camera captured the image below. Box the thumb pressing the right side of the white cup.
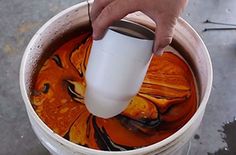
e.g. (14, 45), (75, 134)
(153, 16), (177, 55)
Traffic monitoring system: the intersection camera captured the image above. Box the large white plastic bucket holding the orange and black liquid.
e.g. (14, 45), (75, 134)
(20, 2), (213, 155)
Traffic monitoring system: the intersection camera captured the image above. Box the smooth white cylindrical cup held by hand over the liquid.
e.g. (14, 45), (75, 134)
(85, 20), (154, 118)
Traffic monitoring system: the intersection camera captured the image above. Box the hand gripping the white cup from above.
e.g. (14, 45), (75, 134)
(91, 0), (188, 55)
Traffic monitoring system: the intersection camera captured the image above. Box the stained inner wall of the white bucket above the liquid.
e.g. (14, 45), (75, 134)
(21, 1), (211, 154)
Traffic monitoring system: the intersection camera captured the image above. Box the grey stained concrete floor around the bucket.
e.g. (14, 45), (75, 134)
(0, 0), (236, 155)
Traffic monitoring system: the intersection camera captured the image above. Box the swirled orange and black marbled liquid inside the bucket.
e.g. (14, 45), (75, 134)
(31, 32), (197, 151)
